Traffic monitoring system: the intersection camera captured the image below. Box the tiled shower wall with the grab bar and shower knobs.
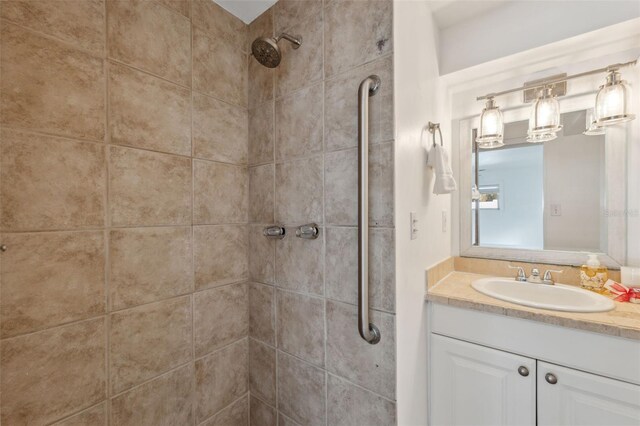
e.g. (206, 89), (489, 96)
(249, 0), (396, 426)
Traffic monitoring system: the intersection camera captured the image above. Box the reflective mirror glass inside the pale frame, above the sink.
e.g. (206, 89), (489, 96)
(471, 111), (607, 253)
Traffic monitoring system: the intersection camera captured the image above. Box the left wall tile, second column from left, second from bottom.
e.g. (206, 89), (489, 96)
(109, 296), (192, 393)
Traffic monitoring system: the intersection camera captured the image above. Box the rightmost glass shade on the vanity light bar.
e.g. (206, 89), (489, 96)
(595, 71), (636, 126)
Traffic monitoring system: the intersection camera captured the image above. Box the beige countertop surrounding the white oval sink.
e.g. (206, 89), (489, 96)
(425, 271), (640, 340)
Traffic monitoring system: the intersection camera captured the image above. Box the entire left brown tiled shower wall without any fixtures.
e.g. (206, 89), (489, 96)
(0, 0), (249, 426)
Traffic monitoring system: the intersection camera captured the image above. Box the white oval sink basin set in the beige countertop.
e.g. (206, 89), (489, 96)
(471, 278), (615, 312)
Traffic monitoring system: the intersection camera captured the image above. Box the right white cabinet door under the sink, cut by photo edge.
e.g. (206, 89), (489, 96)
(538, 361), (640, 426)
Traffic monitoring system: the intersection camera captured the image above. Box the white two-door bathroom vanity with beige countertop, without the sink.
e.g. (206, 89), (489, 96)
(427, 272), (640, 426)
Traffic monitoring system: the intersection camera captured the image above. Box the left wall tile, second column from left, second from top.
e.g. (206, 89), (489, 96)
(109, 63), (191, 155)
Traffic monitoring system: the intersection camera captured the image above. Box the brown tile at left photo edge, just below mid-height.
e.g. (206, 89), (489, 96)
(0, 231), (106, 338)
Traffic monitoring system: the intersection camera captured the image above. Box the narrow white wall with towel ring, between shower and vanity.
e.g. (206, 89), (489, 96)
(393, 0), (451, 426)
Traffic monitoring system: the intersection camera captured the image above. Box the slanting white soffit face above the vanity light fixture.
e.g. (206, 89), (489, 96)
(439, 0), (640, 74)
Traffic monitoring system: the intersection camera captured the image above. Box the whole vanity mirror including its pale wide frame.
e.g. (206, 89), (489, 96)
(460, 105), (627, 267)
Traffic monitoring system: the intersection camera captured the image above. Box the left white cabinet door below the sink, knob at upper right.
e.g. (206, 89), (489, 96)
(429, 334), (536, 426)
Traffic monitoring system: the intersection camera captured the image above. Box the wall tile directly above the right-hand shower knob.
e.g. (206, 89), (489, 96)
(276, 154), (323, 224)
